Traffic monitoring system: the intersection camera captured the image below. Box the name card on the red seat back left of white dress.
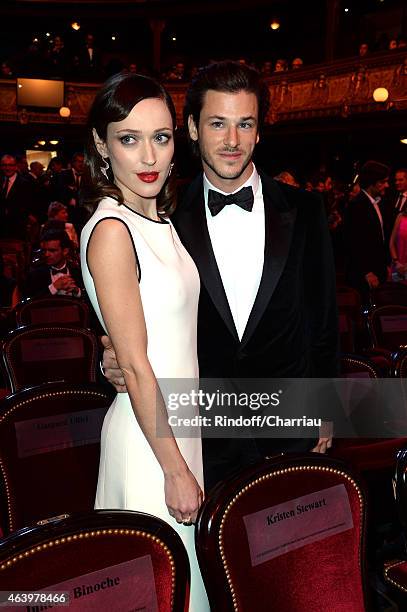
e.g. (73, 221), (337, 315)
(15, 408), (107, 459)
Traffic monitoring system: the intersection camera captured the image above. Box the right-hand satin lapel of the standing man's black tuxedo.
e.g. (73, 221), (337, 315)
(241, 174), (297, 347)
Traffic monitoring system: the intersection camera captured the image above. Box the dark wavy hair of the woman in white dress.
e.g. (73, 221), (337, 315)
(85, 72), (176, 216)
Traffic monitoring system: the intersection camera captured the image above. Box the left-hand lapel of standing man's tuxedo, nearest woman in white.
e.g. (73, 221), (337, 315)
(174, 175), (238, 340)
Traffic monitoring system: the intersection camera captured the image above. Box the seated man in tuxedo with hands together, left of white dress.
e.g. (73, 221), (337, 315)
(23, 230), (83, 298)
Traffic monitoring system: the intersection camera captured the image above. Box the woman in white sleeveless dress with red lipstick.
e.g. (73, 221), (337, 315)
(81, 74), (209, 612)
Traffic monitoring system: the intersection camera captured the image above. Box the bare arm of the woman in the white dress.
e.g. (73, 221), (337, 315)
(88, 219), (202, 522)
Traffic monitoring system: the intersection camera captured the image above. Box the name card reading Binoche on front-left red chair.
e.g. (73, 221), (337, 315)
(2, 555), (158, 612)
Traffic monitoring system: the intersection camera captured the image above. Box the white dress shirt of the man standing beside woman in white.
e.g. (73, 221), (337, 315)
(204, 166), (265, 340)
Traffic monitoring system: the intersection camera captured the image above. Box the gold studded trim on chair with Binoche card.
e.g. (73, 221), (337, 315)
(0, 528), (176, 606)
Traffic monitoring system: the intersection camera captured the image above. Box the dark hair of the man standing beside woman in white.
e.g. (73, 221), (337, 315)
(184, 60), (270, 153)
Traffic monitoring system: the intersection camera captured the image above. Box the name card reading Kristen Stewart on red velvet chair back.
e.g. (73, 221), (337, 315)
(243, 484), (353, 566)
